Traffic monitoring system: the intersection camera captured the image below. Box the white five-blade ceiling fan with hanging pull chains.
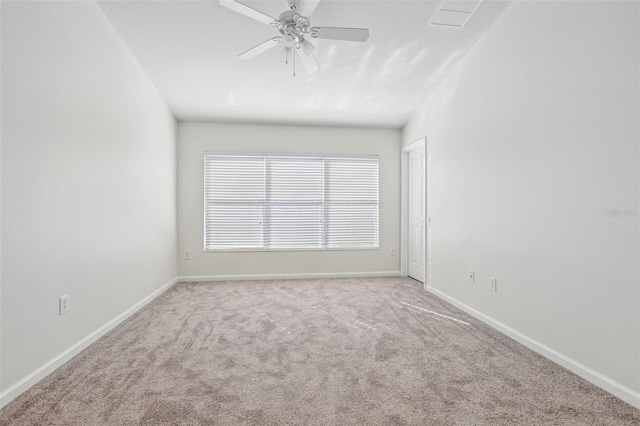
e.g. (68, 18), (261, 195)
(220, 0), (369, 75)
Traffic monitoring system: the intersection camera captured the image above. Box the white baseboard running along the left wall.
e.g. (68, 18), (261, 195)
(0, 278), (178, 408)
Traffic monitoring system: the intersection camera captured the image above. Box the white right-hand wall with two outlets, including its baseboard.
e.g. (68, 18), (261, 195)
(403, 1), (640, 407)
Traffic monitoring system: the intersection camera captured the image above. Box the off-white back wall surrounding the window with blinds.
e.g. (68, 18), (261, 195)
(178, 123), (400, 279)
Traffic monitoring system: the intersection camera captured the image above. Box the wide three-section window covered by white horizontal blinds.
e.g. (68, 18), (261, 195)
(204, 154), (378, 250)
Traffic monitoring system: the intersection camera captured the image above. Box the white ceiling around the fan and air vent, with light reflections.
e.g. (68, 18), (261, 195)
(99, 0), (509, 129)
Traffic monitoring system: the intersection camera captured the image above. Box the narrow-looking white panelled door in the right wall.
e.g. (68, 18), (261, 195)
(407, 146), (426, 283)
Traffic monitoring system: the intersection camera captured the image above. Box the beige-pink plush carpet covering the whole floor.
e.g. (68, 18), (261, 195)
(0, 278), (640, 425)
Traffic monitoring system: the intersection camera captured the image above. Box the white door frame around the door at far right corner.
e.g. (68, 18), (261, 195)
(400, 137), (429, 289)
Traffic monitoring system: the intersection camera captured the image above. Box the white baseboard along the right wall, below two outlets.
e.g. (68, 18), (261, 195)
(426, 287), (640, 409)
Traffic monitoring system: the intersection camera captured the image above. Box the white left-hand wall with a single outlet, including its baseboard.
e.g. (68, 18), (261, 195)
(0, 2), (177, 403)
